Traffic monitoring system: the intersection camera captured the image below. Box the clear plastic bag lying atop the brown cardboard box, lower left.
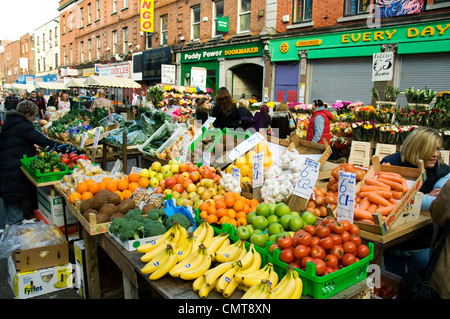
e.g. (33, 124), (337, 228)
(0, 221), (64, 258)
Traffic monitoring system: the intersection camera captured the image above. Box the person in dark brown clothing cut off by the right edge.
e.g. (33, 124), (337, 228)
(430, 181), (450, 299)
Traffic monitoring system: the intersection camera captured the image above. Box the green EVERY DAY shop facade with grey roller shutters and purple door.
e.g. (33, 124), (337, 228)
(269, 20), (450, 105)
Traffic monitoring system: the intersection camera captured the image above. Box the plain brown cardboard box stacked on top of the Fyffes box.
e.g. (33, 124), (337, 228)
(12, 228), (69, 272)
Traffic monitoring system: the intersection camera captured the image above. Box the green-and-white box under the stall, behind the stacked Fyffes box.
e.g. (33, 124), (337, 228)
(37, 187), (77, 227)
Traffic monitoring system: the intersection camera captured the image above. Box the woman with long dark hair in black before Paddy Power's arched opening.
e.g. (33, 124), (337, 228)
(211, 87), (239, 129)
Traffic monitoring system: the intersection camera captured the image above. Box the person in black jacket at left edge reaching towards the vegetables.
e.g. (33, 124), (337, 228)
(0, 101), (55, 225)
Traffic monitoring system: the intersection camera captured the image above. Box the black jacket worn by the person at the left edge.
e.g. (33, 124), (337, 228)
(0, 110), (55, 199)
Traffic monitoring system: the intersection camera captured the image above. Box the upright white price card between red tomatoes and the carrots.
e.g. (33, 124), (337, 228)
(336, 171), (356, 222)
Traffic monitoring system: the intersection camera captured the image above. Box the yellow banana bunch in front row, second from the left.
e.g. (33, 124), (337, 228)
(169, 244), (212, 280)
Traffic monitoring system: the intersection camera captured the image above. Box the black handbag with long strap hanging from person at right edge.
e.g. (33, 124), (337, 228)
(397, 222), (450, 299)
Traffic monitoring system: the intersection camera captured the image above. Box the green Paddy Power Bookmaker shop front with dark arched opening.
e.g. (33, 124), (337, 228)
(177, 43), (265, 100)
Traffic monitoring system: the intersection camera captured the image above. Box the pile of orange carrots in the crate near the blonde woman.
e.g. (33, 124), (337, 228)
(354, 171), (408, 224)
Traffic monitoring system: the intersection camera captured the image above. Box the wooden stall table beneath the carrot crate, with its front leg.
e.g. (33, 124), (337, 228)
(359, 211), (433, 267)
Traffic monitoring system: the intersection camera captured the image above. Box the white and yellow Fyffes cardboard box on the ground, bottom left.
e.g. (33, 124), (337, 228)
(8, 257), (73, 299)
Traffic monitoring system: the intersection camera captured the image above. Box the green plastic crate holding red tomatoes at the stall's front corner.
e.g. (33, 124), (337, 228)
(269, 242), (374, 299)
